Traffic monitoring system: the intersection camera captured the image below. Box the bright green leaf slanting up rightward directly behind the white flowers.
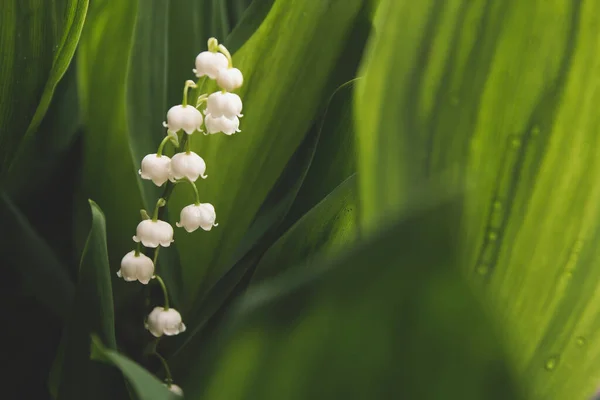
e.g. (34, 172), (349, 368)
(170, 0), (362, 304)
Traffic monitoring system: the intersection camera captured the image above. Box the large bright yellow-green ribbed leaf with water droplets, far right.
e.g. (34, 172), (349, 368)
(356, 0), (600, 400)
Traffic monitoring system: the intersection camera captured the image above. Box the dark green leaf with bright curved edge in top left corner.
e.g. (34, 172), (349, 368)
(0, 0), (88, 177)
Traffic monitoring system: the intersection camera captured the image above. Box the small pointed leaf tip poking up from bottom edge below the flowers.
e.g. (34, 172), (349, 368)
(91, 335), (178, 400)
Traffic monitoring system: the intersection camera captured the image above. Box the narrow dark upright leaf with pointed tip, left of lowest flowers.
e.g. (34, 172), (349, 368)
(58, 200), (117, 400)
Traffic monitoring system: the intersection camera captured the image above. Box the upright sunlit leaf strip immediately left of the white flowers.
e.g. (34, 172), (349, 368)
(77, 0), (143, 265)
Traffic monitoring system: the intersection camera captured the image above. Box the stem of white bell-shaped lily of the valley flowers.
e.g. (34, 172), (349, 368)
(117, 38), (244, 395)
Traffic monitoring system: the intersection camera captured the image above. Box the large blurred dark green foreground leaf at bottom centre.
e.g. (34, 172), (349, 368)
(176, 195), (521, 400)
